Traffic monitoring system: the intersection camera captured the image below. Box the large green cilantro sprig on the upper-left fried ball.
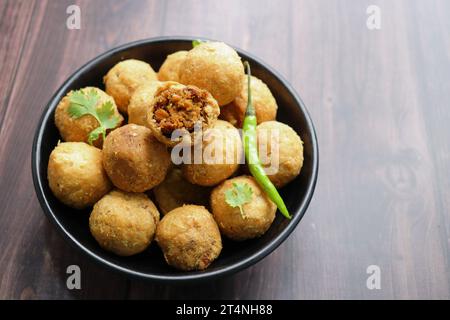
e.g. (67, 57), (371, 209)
(67, 89), (120, 145)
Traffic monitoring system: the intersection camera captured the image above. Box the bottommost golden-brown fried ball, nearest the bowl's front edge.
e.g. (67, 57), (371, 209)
(155, 205), (222, 271)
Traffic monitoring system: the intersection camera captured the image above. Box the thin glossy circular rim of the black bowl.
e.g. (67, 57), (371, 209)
(31, 36), (319, 283)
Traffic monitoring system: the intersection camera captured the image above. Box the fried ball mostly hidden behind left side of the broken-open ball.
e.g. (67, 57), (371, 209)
(128, 81), (162, 126)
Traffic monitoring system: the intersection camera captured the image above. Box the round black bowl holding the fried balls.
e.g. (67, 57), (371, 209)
(32, 37), (318, 282)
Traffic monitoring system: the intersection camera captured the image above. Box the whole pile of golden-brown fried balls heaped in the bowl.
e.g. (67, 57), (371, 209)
(48, 42), (303, 271)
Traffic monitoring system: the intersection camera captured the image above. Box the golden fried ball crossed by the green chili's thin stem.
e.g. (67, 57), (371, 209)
(220, 76), (278, 128)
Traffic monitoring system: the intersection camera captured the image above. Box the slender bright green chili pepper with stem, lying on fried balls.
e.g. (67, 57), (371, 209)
(242, 61), (291, 219)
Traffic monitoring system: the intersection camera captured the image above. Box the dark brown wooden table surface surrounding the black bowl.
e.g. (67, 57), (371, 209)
(0, 0), (450, 299)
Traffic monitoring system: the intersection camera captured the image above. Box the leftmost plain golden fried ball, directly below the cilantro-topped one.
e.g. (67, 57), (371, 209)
(47, 142), (112, 209)
